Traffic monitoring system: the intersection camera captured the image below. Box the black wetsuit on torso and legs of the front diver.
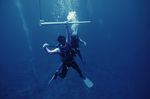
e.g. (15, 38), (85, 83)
(59, 44), (84, 79)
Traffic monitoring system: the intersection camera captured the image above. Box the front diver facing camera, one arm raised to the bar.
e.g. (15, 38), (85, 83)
(43, 24), (85, 79)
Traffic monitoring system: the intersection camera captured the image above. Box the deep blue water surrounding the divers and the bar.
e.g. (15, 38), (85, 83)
(0, 0), (150, 99)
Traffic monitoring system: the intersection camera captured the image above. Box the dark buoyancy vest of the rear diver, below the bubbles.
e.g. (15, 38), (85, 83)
(71, 35), (79, 48)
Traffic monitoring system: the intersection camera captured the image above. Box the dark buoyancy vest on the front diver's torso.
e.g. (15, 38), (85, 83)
(58, 43), (76, 62)
